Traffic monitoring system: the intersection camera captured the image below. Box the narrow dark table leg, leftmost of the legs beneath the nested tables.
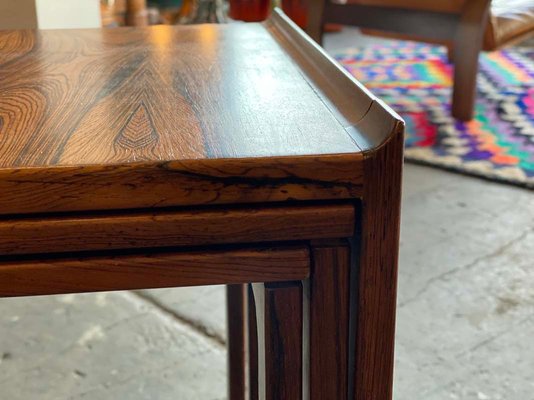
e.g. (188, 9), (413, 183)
(226, 284), (246, 400)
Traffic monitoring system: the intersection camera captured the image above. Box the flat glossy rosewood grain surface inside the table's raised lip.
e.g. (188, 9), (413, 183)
(0, 24), (358, 168)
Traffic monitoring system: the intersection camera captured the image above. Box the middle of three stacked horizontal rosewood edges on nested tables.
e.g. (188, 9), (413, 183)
(0, 204), (355, 255)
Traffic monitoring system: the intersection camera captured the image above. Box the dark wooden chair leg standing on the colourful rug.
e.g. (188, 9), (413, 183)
(452, 0), (490, 121)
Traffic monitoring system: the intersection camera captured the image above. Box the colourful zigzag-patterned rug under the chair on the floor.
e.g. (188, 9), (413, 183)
(336, 41), (534, 188)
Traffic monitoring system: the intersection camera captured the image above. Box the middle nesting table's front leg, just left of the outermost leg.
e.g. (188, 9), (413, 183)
(304, 244), (350, 400)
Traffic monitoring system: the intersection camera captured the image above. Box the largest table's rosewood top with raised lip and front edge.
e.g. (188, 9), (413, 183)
(0, 12), (399, 214)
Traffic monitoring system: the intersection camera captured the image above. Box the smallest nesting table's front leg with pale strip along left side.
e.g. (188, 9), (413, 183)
(253, 282), (302, 400)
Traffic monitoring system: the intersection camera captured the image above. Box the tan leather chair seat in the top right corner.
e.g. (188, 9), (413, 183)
(484, 0), (534, 51)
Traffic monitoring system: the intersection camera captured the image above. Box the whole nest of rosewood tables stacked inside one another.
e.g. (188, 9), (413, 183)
(0, 12), (403, 400)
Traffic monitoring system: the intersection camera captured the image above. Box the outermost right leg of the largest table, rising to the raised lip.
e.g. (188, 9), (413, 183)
(356, 123), (406, 400)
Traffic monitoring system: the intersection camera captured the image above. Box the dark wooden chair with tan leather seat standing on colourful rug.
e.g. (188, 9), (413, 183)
(307, 0), (534, 121)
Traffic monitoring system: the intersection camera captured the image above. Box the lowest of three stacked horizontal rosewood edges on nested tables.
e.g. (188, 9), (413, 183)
(0, 246), (310, 297)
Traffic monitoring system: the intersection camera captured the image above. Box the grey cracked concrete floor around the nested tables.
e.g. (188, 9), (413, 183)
(0, 30), (534, 400)
